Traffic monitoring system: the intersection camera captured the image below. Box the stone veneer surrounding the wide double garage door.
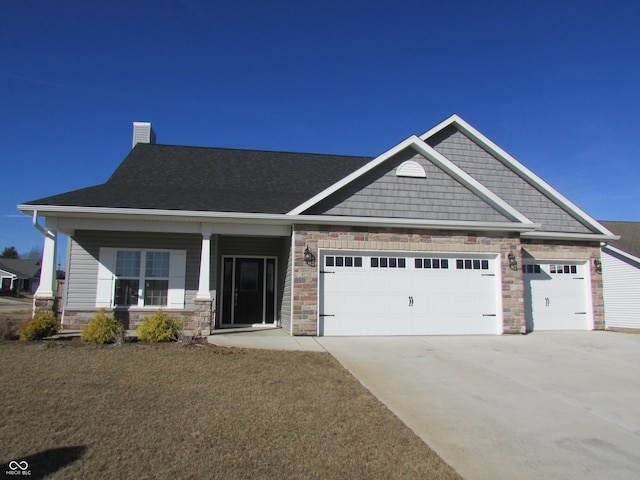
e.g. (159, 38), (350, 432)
(292, 225), (525, 335)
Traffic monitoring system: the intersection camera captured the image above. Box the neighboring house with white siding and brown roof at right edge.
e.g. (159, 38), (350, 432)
(600, 221), (640, 328)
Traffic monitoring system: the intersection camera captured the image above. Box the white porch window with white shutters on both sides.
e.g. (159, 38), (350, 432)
(96, 248), (186, 308)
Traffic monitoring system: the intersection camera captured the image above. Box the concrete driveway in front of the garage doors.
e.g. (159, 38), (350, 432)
(317, 332), (640, 480)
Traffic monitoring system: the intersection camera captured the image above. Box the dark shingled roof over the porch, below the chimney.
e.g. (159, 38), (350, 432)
(27, 143), (371, 213)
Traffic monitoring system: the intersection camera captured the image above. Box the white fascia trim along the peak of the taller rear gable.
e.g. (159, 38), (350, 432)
(420, 114), (613, 235)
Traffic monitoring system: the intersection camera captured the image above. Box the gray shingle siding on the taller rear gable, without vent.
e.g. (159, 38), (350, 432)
(427, 127), (592, 233)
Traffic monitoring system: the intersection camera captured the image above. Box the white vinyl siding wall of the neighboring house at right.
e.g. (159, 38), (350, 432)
(602, 248), (640, 328)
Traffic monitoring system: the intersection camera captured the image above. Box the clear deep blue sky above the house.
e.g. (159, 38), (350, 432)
(0, 0), (640, 262)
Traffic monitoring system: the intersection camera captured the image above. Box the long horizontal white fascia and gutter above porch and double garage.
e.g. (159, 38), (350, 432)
(18, 205), (540, 232)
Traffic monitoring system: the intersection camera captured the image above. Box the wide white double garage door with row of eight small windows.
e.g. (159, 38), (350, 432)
(319, 251), (502, 336)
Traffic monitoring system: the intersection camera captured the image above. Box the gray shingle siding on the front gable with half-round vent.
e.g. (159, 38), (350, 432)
(308, 148), (509, 222)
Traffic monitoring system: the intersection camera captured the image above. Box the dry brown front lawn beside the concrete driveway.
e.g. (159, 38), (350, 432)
(0, 340), (460, 480)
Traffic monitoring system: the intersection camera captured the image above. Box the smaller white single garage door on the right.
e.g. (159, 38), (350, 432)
(522, 261), (593, 331)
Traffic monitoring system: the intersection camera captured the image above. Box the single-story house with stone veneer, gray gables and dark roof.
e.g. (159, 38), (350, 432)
(18, 115), (616, 335)
